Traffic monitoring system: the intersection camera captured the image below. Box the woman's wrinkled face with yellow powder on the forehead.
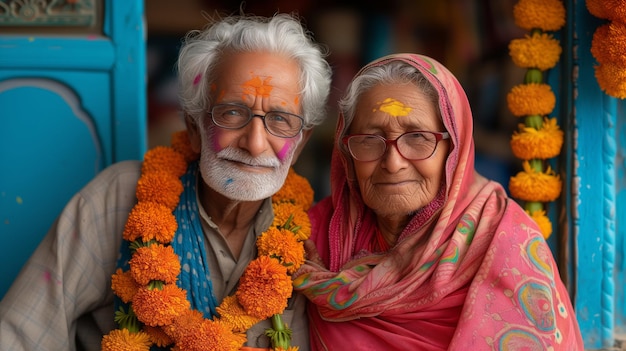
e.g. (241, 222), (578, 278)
(348, 83), (450, 217)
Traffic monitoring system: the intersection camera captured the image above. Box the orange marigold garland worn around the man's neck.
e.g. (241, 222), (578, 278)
(101, 131), (313, 351)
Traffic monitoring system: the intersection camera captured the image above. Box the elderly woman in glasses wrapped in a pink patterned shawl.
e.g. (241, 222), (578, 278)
(295, 54), (583, 351)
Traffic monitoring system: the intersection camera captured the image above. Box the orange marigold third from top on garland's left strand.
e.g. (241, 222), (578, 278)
(135, 171), (183, 211)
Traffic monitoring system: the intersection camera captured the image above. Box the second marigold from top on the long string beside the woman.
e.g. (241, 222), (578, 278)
(509, 33), (561, 71)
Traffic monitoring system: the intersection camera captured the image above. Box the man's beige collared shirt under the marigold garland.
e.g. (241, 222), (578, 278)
(0, 161), (309, 351)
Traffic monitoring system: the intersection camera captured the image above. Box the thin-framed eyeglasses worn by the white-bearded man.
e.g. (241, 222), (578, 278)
(209, 104), (304, 138)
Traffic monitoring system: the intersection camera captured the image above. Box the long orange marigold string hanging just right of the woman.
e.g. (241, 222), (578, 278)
(507, 0), (565, 239)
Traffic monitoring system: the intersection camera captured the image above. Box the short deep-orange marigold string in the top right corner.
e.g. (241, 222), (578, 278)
(585, 0), (626, 99)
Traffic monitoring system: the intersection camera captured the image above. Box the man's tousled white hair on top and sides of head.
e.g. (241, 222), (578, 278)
(177, 14), (332, 129)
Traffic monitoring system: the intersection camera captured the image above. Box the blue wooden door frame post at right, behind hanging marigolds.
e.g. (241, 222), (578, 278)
(550, 0), (626, 350)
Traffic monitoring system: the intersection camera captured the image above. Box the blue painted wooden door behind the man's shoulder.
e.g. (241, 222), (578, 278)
(0, 0), (147, 298)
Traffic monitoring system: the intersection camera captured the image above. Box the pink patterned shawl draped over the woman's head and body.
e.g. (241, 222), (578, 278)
(294, 54), (583, 351)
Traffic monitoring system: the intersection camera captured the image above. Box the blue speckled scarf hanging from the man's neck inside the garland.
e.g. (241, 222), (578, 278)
(115, 162), (217, 330)
